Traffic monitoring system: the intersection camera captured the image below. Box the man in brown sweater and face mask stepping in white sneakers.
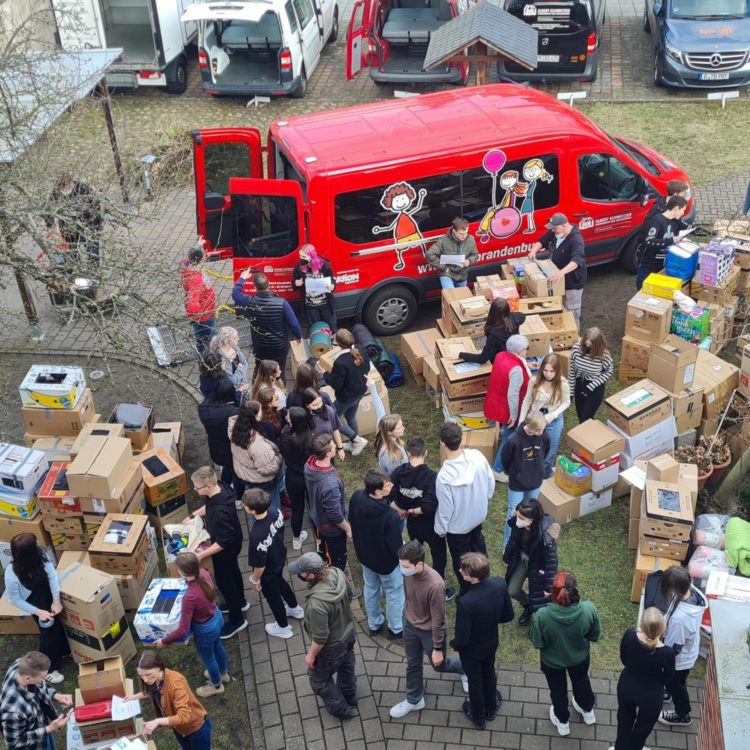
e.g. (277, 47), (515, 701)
(390, 539), (469, 719)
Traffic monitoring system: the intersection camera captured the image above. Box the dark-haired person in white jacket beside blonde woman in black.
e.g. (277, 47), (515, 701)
(659, 565), (708, 727)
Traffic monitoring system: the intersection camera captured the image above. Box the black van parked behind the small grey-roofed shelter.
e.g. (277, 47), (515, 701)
(497, 0), (605, 81)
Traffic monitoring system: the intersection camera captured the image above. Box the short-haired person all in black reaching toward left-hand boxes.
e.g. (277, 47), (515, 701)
(185, 466), (250, 639)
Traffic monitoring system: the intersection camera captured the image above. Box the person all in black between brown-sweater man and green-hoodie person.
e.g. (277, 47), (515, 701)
(451, 552), (513, 729)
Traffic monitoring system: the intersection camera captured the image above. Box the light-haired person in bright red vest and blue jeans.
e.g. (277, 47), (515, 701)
(484, 335), (531, 482)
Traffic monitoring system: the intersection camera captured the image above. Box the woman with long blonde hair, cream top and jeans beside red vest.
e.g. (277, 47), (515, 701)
(519, 354), (570, 479)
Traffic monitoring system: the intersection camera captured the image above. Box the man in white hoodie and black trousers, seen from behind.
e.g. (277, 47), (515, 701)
(435, 422), (495, 594)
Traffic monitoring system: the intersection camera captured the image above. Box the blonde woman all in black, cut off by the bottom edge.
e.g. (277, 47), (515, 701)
(609, 607), (675, 750)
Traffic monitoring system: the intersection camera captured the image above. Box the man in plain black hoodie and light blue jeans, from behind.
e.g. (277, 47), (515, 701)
(349, 469), (405, 640)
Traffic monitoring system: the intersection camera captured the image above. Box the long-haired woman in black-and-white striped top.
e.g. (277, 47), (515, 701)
(568, 327), (615, 423)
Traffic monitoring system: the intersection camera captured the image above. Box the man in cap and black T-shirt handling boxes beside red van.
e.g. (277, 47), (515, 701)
(529, 213), (586, 329)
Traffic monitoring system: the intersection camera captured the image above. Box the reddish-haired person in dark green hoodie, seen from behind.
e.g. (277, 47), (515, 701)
(529, 570), (601, 737)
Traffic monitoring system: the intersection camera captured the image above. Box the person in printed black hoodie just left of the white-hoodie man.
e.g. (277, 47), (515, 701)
(391, 436), (456, 602)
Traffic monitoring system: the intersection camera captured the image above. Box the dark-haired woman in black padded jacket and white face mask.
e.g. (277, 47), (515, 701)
(503, 500), (560, 625)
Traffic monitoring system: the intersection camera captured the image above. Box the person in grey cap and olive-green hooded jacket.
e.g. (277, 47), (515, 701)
(289, 552), (357, 719)
